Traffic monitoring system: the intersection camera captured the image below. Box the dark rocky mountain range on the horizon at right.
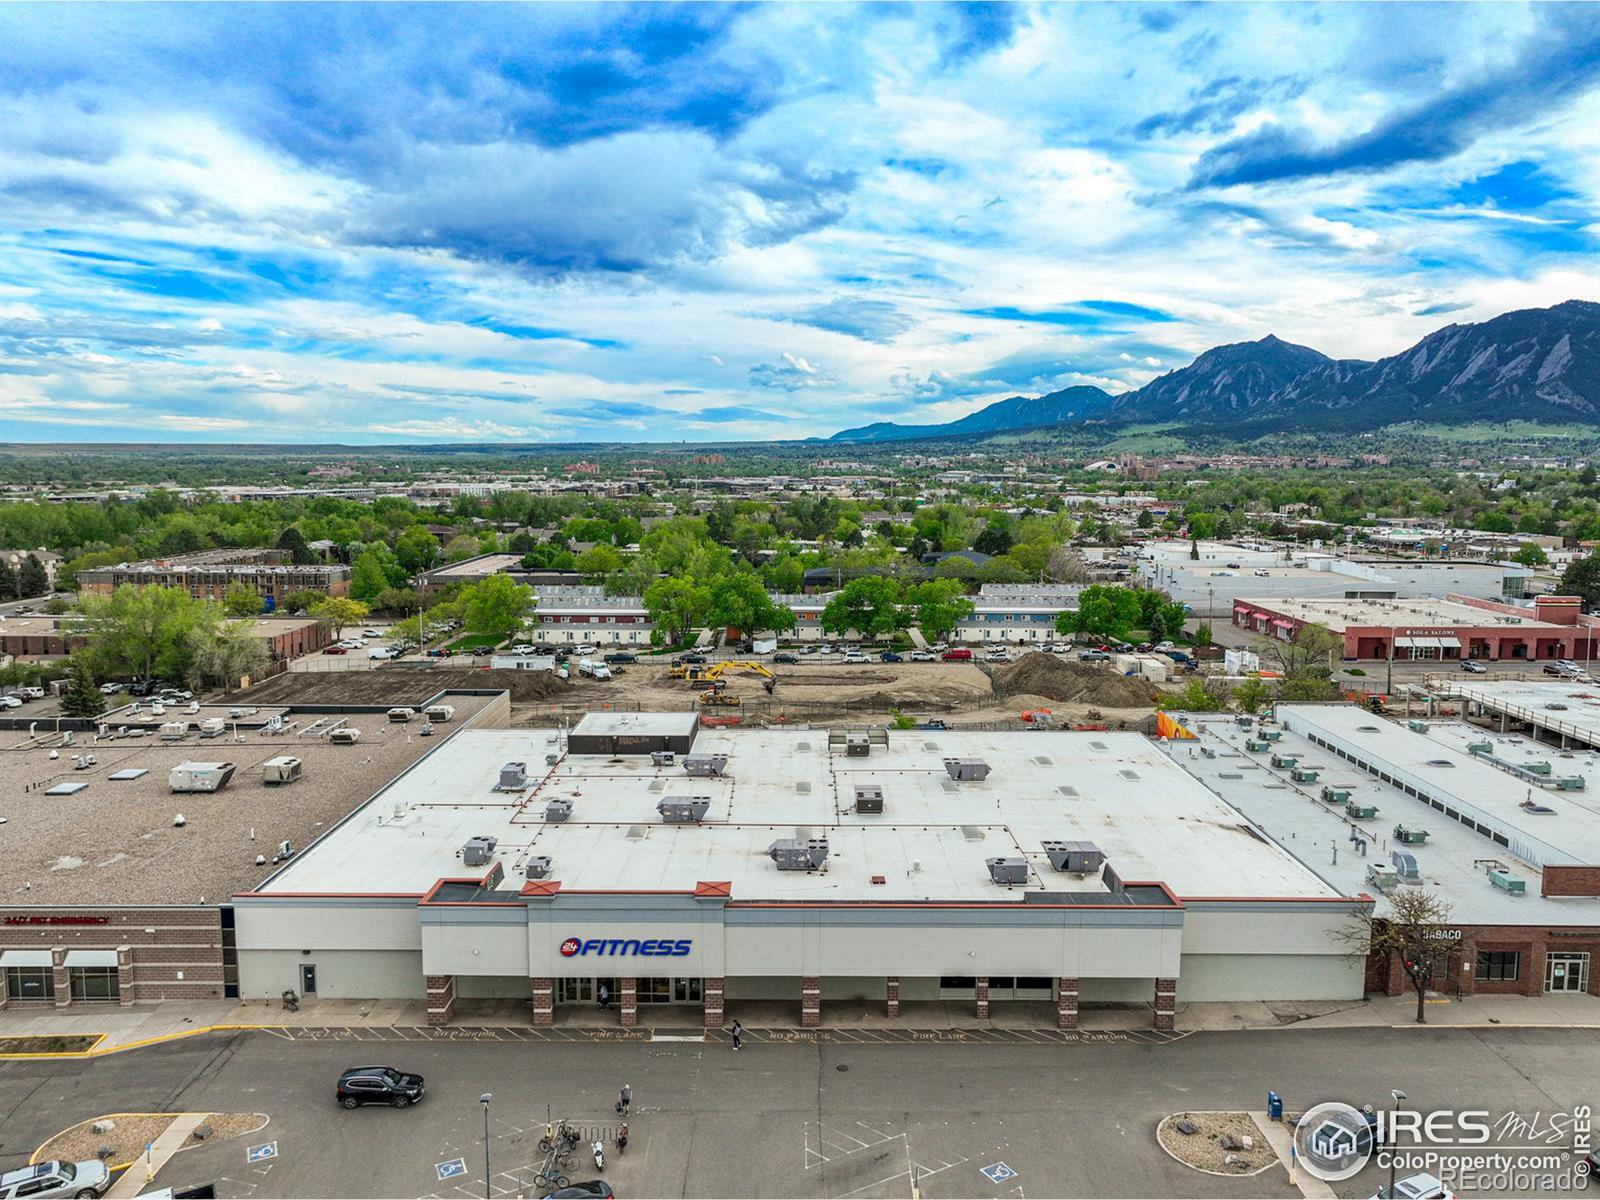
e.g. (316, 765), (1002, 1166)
(829, 301), (1600, 442)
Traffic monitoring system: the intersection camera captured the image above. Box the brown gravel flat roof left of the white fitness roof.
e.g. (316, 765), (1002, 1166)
(0, 696), (485, 904)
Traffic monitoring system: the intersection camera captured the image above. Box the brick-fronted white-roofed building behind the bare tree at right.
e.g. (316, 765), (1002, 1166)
(1171, 704), (1600, 995)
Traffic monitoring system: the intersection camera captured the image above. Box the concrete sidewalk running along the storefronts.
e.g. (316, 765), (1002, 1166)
(0, 995), (1600, 1058)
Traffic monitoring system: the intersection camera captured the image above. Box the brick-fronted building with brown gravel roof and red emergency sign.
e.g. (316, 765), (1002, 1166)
(0, 694), (509, 1006)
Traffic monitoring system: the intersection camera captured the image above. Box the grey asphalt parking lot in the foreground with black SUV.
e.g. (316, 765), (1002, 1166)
(0, 1029), (1600, 1198)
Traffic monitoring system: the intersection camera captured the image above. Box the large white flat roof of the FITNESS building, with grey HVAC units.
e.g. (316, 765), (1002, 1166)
(264, 714), (1338, 902)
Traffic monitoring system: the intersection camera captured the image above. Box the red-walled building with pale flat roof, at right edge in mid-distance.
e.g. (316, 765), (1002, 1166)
(1234, 595), (1600, 662)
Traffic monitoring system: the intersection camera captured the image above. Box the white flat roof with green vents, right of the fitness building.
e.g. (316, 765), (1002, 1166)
(1171, 706), (1600, 925)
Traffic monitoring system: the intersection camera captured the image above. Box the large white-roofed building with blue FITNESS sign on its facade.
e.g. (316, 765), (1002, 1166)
(234, 714), (1370, 1029)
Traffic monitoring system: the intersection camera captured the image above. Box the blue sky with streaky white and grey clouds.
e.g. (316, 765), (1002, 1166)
(0, 3), (1600, 442)
